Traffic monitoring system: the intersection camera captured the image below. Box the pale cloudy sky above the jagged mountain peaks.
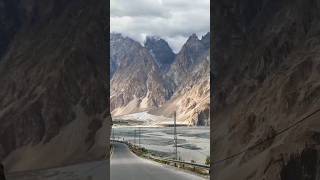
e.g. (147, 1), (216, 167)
(110, 0), (210, 53)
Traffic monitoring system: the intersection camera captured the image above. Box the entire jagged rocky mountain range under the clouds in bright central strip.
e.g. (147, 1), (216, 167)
(110, 33), (210, 125)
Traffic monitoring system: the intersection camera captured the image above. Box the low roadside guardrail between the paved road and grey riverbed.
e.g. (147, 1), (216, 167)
(111, 140), (210, 173)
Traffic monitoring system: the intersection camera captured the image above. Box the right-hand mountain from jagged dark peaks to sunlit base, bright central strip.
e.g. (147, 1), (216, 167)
(162, 33), (210, 126)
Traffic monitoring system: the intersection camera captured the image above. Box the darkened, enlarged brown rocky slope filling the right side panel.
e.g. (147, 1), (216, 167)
(211, 0), (320, 180)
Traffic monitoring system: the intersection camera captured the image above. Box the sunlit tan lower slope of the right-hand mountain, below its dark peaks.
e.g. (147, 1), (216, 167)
(149, 51), (210, 126)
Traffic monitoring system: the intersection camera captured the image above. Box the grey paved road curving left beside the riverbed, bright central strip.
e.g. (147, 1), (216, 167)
(110, 143), (203, 180)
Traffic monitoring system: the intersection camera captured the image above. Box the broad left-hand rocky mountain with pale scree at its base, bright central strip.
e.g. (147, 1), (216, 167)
(110, 34), (171, 115)
